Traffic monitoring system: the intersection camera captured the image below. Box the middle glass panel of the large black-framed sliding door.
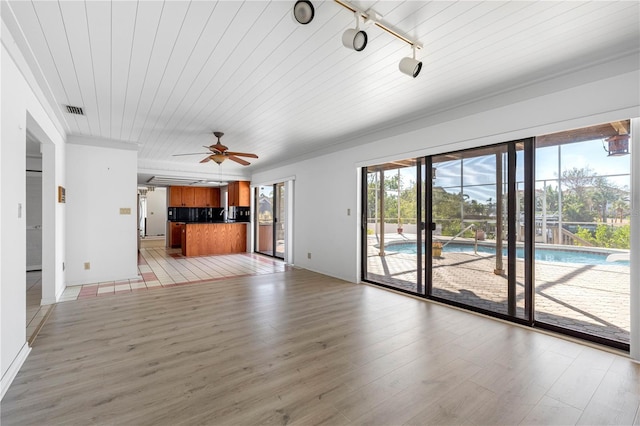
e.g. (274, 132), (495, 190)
(431, 144), (524, 317)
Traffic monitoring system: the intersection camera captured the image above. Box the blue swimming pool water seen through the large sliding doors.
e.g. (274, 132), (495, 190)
(386, 243), (629, 267)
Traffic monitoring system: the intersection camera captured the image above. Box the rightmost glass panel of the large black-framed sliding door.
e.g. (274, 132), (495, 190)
(535, 121), (631, 344)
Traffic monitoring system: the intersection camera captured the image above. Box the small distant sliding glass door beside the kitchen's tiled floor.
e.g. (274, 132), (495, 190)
(254, 182), (286, 259)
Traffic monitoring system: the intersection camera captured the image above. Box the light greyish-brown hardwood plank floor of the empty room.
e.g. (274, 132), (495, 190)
(1, 269), (640, 426)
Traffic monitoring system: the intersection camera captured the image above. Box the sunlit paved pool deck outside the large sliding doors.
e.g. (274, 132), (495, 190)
(367, 234), (630, 343)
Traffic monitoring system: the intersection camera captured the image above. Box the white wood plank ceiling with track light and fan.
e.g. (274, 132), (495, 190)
(3, 0), (640, 181)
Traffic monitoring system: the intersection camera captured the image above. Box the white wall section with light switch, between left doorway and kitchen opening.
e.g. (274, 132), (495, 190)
(66, 141), (138, 285)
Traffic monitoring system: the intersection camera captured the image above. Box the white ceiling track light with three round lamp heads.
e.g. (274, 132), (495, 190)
(293, 0), (422, 78)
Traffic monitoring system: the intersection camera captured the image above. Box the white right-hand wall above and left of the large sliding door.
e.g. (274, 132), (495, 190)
(252, 60), (640, 282)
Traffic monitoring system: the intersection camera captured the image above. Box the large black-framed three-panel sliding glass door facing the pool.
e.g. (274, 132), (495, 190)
(362, 120), (632, 350)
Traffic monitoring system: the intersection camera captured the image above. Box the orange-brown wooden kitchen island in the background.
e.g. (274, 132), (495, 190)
(182, 222), (249, 256)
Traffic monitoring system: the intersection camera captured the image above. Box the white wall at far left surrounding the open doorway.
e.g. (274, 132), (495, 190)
(0, 22), (64, 396)
